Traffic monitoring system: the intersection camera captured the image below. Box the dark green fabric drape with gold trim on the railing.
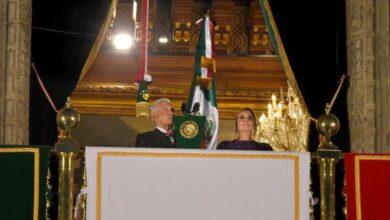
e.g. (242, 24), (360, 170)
(0, 146), (49, 220)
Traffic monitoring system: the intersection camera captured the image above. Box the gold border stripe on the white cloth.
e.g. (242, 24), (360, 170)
(96, 152), (300, 220)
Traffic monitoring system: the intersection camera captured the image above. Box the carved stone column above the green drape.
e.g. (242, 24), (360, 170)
(0, 0), (32, 144)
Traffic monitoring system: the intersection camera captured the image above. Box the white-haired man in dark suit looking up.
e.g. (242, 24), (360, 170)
(135, 98), (176, 148)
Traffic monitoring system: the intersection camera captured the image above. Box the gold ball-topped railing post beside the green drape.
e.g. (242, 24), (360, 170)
(55, 98), (80, 220)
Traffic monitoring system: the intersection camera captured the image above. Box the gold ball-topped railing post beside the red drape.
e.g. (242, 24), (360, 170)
(316, 109), (342, 220)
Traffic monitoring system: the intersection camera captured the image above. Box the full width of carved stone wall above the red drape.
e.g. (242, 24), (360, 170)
(346, 0), (390, 152)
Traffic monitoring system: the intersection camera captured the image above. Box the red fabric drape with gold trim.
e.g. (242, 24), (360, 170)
(344, 153), (390, 220)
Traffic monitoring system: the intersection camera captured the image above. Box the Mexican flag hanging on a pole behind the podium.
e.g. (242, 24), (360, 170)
(188, 16), (219, 149)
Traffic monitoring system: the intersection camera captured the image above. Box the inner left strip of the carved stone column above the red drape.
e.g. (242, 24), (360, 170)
(347, 0), (375, 152)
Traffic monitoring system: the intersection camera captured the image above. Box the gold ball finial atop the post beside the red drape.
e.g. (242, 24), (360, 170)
(316, 114), (340, 150)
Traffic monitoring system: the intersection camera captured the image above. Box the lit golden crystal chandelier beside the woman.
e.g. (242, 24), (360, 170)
(254, 83), (310, 152)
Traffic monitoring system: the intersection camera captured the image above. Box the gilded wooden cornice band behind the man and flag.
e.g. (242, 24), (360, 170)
(72, 84), (282, 119)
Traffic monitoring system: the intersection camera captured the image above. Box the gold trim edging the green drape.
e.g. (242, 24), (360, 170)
(0, 148), (39, 220)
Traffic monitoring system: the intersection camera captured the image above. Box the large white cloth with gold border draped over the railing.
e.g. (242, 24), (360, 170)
(86, 147), (310, 220)
